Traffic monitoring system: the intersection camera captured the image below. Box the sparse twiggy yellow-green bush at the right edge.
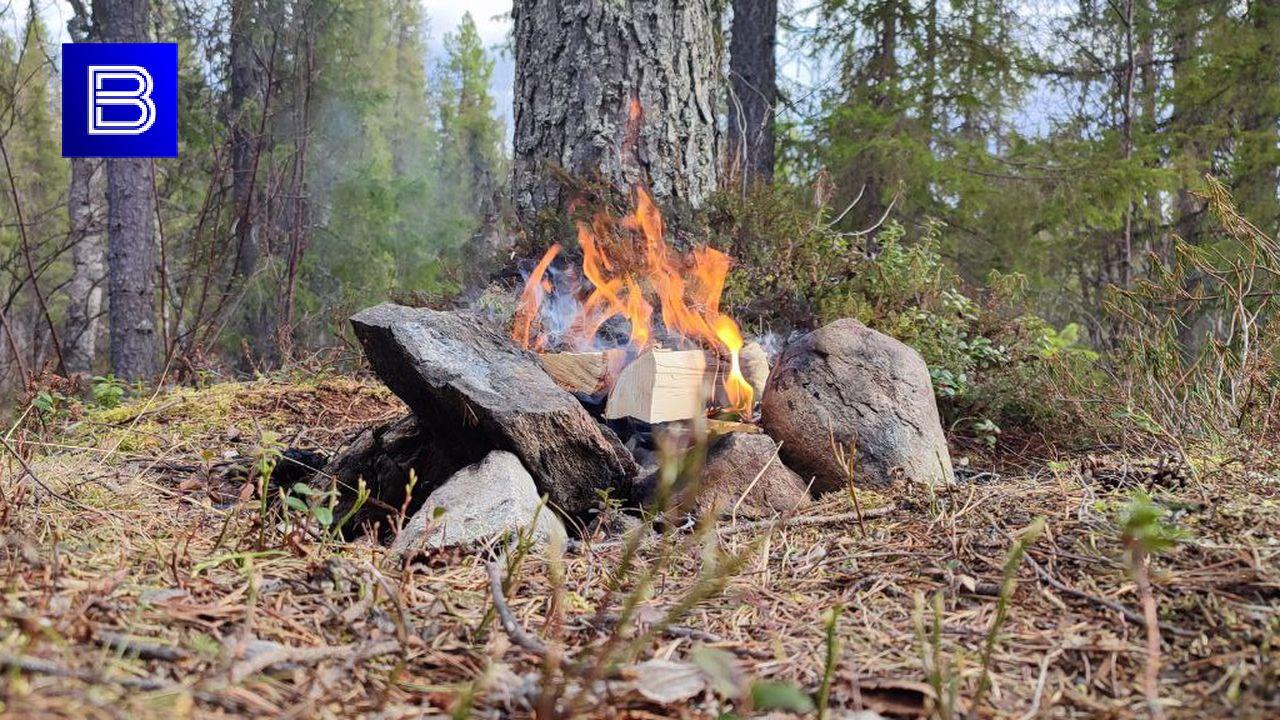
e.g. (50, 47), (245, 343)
(1108, 178), (1280, 442)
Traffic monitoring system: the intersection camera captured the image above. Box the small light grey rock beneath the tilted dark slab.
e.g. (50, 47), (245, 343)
(392, 450), (564, 553)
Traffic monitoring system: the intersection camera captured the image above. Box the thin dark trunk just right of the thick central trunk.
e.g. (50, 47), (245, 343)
(728, 0), (778, 182)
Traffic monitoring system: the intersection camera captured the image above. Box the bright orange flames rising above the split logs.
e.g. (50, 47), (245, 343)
(512, 187), (754, 418)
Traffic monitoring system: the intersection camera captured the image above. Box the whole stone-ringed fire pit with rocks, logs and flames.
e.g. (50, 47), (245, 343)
(324, 188), (952, 551)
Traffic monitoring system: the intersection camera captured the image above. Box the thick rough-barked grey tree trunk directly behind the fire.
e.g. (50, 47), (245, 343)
(512, 0), (719, 234)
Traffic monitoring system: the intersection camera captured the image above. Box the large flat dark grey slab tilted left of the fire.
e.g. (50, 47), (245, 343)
(351, 304), (636, 515)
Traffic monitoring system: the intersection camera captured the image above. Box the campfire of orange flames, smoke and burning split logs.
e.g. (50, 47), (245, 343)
(512, 186), (768, 423)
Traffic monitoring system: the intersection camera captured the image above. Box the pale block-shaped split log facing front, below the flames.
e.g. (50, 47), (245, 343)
(604, 348), (714, 423)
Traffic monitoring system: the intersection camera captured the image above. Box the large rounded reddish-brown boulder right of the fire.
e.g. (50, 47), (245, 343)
(760, 319), (954, 492)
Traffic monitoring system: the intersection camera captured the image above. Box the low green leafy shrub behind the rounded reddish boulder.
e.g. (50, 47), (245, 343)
(707, 187), (1098, 446)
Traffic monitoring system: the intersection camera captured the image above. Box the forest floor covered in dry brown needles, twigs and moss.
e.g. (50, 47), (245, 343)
(0, 375), (1280, 717)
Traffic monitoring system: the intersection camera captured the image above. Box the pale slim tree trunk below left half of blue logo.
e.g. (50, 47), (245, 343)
(63, 158), (106, 375)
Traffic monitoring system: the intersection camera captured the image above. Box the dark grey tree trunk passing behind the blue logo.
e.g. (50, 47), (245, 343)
(93, 0), (156, 380)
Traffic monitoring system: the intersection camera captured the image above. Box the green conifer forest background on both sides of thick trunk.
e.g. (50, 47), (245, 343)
(0, 0), (1280, 445)
